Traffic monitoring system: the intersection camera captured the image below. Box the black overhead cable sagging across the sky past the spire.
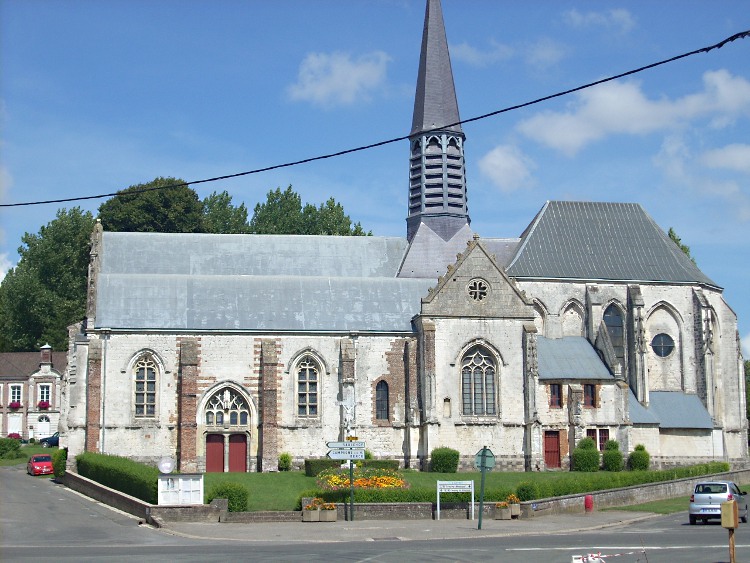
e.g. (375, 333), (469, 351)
(0, 30), (750, 207)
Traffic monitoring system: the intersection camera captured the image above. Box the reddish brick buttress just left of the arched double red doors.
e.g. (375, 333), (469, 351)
(177, 338), (200, 472)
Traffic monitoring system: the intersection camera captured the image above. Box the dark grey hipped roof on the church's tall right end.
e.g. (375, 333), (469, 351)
(508, 201), (718, 287)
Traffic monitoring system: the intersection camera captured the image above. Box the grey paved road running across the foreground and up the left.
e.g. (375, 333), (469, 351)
(0, 466), (750, 563)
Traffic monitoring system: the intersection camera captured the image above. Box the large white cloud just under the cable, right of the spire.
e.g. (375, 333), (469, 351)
(518, 70), (750, 156)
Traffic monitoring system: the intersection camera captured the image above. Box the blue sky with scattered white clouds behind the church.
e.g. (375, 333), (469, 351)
(0, 0), (750, 358)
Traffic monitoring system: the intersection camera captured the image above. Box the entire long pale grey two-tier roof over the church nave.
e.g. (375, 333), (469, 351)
(95, 232), (437, 332)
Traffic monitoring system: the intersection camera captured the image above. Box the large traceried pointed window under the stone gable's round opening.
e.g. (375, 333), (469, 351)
(461, 346), (496, 415)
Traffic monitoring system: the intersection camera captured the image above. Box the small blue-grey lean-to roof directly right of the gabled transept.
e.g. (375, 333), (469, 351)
(537, 336), (613, 381)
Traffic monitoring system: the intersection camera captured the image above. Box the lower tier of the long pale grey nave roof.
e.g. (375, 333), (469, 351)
(96, 274), (434, 332)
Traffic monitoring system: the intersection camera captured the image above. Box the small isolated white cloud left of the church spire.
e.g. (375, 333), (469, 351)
(287, 51), (390, 107)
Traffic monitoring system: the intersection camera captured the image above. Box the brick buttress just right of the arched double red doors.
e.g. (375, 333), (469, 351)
(258, 339), (283, 471)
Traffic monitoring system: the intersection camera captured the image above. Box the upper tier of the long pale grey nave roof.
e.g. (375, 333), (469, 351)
(101, 232), (407, 278)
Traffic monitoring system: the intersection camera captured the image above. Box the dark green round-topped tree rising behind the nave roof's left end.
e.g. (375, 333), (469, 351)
(99, 177), (203, 233)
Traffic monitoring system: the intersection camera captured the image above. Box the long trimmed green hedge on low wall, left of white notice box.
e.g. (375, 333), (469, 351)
(76, 452), (159, 504)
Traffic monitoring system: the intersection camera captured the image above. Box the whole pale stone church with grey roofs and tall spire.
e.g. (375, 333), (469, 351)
(60, 0), (748, 472)
